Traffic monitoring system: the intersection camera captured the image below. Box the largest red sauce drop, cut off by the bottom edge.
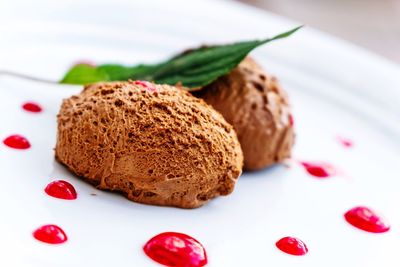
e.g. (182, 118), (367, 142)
(143, 232), (207, 267)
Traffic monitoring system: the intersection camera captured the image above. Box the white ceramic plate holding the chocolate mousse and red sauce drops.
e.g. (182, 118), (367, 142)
(0, 0), (400, 267)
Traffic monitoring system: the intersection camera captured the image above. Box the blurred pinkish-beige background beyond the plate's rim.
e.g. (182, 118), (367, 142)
(235, 0), (400, 63)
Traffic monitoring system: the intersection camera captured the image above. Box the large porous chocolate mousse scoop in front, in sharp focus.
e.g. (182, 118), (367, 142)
(55, 81), (243, 208)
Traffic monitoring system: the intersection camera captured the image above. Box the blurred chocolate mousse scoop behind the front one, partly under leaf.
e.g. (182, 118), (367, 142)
(195, 57), (294, 170)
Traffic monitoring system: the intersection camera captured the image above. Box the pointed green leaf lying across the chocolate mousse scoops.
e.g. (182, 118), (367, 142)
(61, 26), (302, 90)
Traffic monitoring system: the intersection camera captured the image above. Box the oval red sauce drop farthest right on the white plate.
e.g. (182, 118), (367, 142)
(344, 206), (390, 233)
